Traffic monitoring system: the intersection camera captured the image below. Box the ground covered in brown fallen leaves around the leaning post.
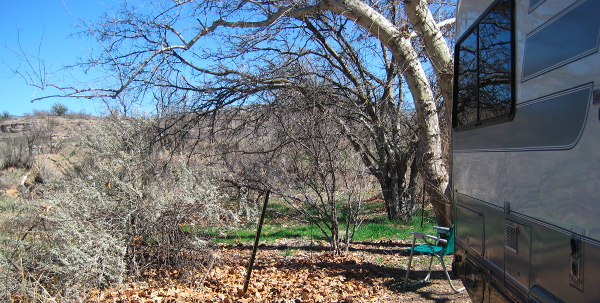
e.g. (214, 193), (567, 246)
(88, 240), (471, 303)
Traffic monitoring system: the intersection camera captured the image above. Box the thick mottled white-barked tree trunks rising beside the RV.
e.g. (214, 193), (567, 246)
(318, 0), (452, 225)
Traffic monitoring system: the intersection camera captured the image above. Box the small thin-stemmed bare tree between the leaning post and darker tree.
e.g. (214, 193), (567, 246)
(273, 94), (372, 253)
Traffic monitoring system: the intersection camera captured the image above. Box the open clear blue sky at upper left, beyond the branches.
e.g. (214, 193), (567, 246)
(0, 0), (117, 116)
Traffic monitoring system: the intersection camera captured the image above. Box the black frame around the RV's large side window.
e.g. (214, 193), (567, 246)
(452, 0), (516, 131)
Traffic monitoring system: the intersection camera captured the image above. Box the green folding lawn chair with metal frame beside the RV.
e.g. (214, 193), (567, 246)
(404, 226), (465, 292)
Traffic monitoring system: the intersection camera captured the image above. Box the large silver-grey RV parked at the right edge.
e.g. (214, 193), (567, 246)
(452, 0), (600, 302)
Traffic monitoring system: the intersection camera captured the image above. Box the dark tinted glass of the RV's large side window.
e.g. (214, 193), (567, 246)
(454, 0), (513, 127)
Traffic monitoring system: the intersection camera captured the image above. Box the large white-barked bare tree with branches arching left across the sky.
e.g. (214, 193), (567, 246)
(22, 0), (452, 224)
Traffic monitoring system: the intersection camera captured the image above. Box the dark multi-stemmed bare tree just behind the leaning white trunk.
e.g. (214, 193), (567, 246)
(300, 15), (421, 220)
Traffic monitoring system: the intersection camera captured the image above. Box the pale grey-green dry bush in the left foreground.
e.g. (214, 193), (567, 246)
(0, 117), (233, 300)
